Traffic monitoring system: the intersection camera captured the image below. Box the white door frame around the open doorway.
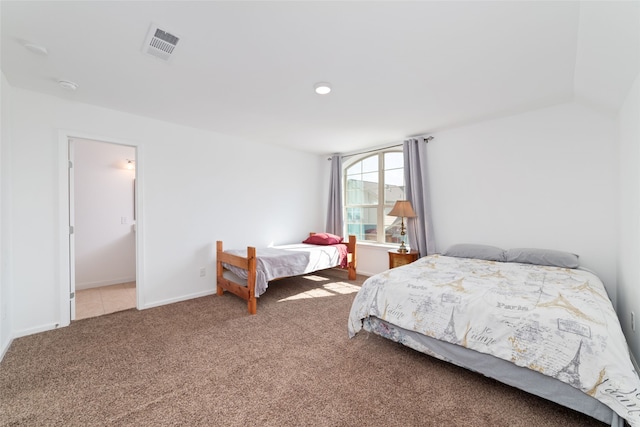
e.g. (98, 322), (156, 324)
(58, 130), (144, 326)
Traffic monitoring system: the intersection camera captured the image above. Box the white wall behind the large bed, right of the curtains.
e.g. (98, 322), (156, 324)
(428, 103), (618, 302)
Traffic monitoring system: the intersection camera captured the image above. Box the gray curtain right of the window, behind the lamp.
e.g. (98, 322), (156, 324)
(402, 137), (436, 256)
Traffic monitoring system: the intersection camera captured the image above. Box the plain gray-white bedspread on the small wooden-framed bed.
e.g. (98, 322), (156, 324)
(224, 243), (340, 297)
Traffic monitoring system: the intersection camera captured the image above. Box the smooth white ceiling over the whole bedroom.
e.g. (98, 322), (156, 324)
(0, 0), (640, 153)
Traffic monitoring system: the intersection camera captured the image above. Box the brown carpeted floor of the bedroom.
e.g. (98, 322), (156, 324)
(0, 270), (603, 427)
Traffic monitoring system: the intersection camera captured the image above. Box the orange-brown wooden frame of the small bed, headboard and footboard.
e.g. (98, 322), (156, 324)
(216, 233), (356, 314)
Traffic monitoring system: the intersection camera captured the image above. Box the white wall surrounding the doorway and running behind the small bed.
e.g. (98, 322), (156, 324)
(5, 88), (326, 336)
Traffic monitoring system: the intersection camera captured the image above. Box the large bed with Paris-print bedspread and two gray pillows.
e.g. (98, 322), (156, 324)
(348, 245), (640, 427)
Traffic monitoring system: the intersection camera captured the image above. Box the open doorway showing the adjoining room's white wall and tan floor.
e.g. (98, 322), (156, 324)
(69, 138), (136, 320)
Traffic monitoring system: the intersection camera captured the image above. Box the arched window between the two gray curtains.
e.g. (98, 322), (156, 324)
(343, 149), (405, 243)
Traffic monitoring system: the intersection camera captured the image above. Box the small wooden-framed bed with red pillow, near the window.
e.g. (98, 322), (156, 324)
(216, 233), (356, 314)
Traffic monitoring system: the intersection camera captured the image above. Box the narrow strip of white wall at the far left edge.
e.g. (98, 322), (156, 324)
(0, 73), (13, 360)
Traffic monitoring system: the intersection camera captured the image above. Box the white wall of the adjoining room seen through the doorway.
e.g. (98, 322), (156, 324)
(72, 139), (136, 289)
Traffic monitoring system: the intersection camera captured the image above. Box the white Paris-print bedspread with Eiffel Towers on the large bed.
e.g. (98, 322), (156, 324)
(348, 255), (640, 427)
